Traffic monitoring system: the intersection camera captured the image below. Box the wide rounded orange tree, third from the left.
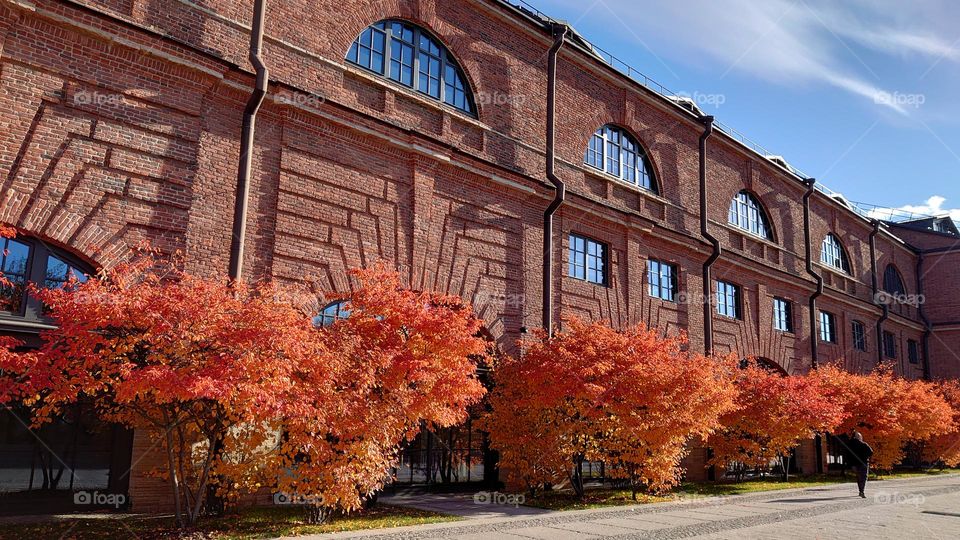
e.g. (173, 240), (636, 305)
(484, 319), (734, 496)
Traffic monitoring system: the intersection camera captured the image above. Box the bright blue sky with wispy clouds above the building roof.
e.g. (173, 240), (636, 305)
(527, 0), (960, 220)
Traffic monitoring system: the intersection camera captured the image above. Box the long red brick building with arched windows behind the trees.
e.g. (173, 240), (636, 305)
(0, 0), (960, 510)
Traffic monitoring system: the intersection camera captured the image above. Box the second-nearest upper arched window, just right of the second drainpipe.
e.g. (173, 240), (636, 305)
(583, 125), (657, 193)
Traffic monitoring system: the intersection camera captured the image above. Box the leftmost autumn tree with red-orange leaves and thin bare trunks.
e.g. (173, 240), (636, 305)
(0, 256), (323, 525)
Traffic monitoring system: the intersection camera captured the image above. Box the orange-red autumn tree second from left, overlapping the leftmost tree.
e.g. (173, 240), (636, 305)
(280, 265), (488, 520)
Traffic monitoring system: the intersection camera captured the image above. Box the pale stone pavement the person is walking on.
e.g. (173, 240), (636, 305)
(290, 475), (960, 540)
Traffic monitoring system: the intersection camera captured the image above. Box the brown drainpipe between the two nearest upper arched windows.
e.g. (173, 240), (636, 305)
(543, 23), (569, 336)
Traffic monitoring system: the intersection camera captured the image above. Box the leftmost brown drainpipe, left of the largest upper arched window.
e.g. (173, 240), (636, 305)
(230, 0), (270, 282)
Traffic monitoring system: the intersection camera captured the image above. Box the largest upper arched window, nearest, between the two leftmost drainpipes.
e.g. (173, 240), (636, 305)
(347, 20), (476, 116)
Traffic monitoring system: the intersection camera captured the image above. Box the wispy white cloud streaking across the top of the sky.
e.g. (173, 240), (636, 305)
(559, 0), (960, 115)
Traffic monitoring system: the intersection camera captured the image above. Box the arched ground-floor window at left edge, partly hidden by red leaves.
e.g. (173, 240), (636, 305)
(0, 236), (94, 326)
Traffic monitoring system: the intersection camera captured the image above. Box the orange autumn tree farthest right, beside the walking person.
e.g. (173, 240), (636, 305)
(815, 366), (953, 470)
